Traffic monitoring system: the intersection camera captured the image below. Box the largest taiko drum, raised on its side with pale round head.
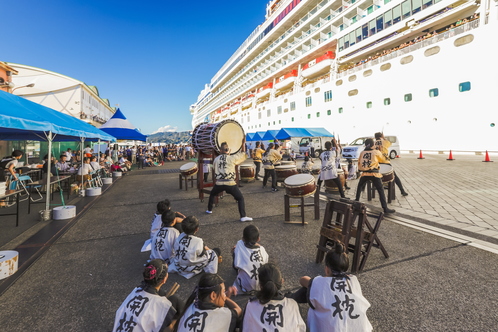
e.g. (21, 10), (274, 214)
(192, 120), (245, 154)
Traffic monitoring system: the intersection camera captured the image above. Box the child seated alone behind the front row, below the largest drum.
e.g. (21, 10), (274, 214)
(233, 225), (268, 293)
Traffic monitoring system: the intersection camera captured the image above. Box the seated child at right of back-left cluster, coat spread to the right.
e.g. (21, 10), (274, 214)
(170, 216), (221, 279)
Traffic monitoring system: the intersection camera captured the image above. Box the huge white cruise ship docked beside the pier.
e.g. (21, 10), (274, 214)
(190, 0), (498, 152)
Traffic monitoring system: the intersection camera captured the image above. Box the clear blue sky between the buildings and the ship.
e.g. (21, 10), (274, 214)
(0, 0), (269, 134)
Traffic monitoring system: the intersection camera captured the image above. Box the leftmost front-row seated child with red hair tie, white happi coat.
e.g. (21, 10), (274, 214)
(112, 259), (183, 332)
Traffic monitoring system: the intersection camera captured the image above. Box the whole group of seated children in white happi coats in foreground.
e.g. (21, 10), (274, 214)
(113, 197), (372, 332)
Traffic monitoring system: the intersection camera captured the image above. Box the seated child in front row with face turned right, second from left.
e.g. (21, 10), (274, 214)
(177, 273), (242, 332)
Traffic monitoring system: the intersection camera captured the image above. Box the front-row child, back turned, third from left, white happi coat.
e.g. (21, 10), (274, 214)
(241, 263), (308, 332)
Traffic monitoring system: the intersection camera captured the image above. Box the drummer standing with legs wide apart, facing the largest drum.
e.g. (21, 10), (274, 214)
(206, 139), (252, 222)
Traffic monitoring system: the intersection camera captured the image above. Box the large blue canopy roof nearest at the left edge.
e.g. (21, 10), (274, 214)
(0, 91), (115, 141)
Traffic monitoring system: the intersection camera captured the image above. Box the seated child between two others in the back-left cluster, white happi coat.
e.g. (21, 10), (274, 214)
(150, 211), (180, 264)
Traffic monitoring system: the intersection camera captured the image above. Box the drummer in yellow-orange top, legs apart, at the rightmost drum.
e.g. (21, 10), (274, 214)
(356, 138), (396, 213)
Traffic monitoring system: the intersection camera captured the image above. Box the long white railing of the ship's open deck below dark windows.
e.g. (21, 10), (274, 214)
(337, 19), (480, 78)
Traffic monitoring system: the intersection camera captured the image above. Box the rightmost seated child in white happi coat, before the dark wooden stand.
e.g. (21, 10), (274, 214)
(298, 241), (372, 332)
